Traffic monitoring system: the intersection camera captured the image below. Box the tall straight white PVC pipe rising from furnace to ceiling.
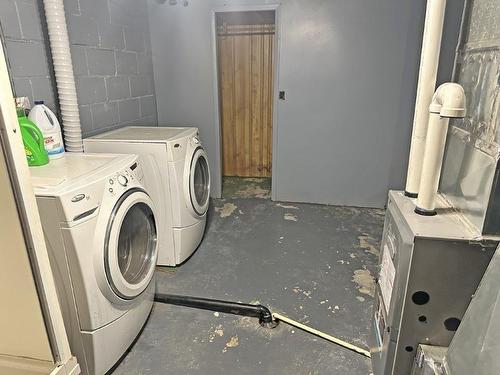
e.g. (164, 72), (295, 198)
(405, 0), (446, 197)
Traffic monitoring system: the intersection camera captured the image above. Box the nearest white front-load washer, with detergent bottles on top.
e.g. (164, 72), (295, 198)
(30, 153), (157, 375)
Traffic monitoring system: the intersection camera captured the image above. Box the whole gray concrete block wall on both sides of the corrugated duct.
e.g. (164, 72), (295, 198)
(0, 0), (157, 136)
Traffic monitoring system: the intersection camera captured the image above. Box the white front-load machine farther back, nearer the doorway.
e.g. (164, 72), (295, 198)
(84, 126), (210, 266)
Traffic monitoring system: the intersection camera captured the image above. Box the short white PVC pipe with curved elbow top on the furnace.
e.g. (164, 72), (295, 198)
(415, 83), (465, 216)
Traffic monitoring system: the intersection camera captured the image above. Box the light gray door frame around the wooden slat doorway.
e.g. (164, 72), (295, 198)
(211, 3), (281, 200)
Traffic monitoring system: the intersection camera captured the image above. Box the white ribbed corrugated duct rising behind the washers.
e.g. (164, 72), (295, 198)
(43, 0), (83, 152)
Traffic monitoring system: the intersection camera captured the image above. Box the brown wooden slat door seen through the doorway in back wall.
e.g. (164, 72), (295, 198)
(217, 25), (274, 177)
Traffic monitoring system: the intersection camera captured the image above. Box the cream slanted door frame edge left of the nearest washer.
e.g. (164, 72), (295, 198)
(0, 35), (78, 366)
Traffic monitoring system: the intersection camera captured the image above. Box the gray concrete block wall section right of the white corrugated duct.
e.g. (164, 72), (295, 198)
(65, 0), (157, 135)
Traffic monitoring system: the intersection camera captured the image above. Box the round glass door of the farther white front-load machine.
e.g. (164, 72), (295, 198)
(189, 147), (210, 216)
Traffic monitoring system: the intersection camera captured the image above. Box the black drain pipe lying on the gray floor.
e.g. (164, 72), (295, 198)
(155, 293), (278, 328)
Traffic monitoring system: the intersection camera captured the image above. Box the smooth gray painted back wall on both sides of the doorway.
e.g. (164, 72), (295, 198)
(148, 0), (463, 207)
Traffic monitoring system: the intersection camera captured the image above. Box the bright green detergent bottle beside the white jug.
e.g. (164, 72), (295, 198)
(17, 109), (49, 167)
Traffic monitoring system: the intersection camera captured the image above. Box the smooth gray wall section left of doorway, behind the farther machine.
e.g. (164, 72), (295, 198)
(148, 0), (221, 197)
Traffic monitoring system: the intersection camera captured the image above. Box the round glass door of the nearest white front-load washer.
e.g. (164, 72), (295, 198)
(104, 189), (157, 299)
